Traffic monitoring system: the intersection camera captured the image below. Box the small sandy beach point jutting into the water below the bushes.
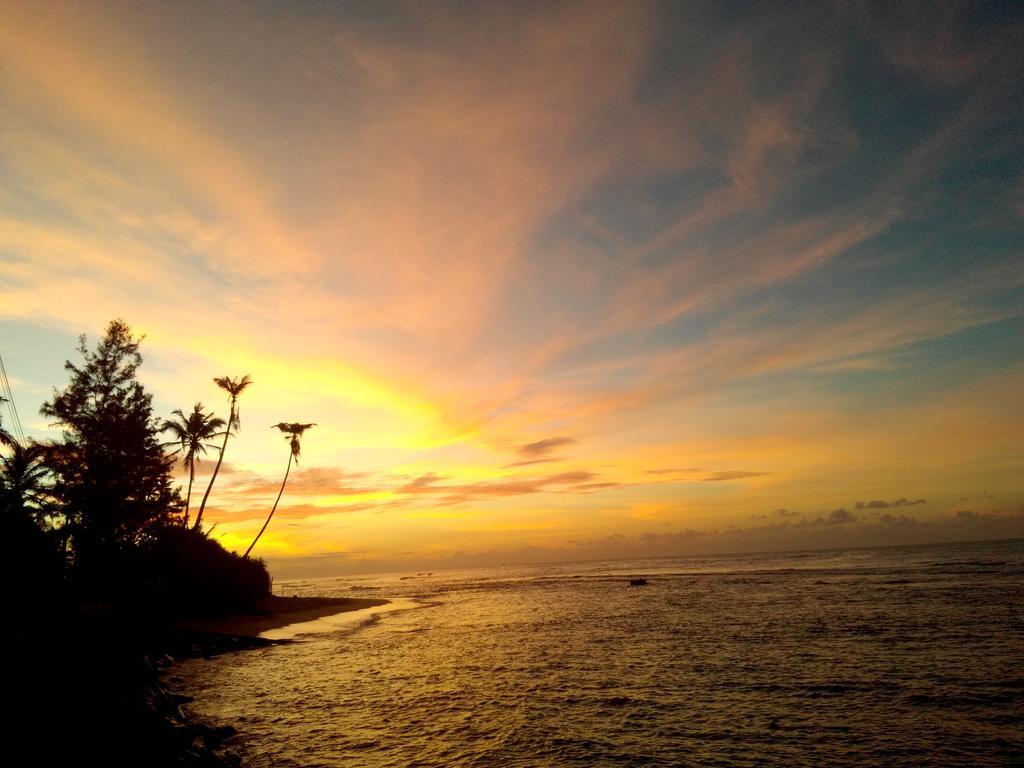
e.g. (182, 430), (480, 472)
(178, 595), (388, 637)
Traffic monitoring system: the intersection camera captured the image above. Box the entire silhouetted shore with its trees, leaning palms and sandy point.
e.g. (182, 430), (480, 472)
(0, 321), (387, 767)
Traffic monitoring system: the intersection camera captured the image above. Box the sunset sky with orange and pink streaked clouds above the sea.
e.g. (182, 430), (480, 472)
(0, 0), (1024, 577)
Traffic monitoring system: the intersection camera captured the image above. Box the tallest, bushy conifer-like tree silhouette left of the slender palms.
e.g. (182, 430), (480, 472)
(40, 319), (179, 574)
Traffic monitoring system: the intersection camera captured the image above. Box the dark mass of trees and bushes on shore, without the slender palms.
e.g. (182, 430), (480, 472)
(0, 319), (270, 612)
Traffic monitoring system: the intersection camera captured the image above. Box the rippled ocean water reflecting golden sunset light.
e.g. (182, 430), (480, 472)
(172, 541), (1024, 768)
